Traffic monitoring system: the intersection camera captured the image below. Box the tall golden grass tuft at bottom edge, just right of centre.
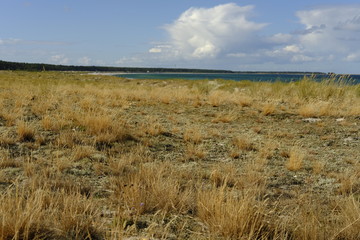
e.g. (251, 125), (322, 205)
(197, 183), (271, 239)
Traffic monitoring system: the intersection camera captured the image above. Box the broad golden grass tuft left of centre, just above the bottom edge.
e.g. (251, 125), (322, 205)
(110, 164), (193, 215)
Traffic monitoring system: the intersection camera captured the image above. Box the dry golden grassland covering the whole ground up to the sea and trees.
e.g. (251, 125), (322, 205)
(0, 71), (360, 240)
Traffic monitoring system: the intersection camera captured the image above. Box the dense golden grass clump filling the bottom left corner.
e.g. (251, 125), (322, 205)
(0, 188), (102, 239)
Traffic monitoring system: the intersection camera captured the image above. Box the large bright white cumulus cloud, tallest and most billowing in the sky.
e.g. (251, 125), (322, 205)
(165, 3), (267, 59)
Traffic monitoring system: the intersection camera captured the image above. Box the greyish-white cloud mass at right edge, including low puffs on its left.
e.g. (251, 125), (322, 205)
(261, 5), (360, 65)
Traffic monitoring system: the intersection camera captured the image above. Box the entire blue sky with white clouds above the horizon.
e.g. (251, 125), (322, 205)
(0, 0), (360, 74)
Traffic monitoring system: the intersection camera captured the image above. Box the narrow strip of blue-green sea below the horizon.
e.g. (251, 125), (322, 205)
(116, 73), (360, 84)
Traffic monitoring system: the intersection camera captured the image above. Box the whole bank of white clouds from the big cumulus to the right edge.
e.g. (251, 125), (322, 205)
(149, 3), (360, 71)
